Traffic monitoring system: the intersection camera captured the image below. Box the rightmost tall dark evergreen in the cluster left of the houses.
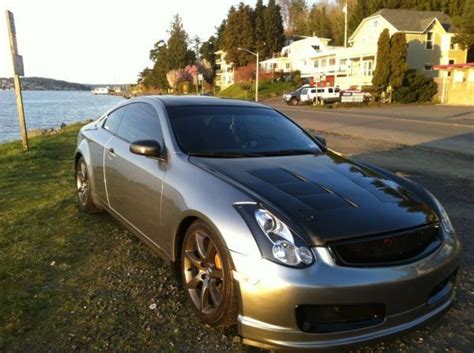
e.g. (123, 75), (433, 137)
(264, 0), (285, 57)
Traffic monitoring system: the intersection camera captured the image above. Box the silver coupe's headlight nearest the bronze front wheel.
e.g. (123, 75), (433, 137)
(235, 204), (314, 267)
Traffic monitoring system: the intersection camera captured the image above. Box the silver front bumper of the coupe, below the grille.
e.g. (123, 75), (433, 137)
(231, 231), (461, 351)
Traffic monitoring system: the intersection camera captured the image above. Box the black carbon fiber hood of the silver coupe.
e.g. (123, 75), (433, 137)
(190, 152), (437, 245)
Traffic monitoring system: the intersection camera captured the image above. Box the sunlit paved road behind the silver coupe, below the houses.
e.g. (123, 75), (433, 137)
(269, 100), (474, 157)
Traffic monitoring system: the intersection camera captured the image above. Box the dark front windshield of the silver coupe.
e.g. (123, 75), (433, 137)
(167, 106), (321, 158)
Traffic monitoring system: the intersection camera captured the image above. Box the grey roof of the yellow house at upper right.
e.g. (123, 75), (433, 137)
(369, 9), (456, 32)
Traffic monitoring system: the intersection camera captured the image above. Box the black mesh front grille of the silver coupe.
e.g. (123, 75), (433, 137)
(328, 223), (442, 267)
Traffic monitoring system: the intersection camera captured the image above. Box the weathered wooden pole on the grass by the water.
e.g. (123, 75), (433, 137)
(5, 10), (29, 151)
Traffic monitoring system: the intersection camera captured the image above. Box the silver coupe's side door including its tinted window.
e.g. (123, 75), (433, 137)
(104, 102), (166, 246)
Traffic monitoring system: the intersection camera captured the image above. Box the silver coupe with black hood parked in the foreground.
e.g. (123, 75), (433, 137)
(74, 96), (461, 352)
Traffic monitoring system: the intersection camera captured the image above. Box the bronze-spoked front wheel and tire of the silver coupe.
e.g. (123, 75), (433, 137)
(180, 220), (239, 327)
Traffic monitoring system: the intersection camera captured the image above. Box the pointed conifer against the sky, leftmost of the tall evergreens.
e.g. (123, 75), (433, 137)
(167, 14), (192, 70)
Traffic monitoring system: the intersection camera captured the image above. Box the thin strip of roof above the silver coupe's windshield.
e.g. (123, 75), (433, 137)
(148, 95), (270, 108)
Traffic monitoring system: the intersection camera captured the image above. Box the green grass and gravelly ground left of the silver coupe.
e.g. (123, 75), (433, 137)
(0, 125), (253, 352)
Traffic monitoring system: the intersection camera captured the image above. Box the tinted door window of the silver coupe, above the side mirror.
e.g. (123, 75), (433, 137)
(117, 103), (163, 143)
